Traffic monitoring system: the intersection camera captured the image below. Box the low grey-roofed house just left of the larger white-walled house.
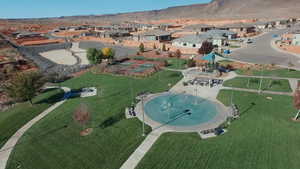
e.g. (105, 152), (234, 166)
(133, 30), (171, 42)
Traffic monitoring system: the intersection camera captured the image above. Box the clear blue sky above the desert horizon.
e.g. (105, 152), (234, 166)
(0, 0), (210, 18)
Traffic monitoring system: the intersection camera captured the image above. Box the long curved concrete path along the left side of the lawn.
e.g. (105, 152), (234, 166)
(0, 87), (71, 169)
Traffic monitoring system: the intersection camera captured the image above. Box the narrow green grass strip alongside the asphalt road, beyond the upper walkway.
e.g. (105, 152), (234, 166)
(236, 69), (300, 78)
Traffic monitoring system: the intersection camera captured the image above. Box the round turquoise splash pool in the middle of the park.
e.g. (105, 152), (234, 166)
(144, 94), (219, 126)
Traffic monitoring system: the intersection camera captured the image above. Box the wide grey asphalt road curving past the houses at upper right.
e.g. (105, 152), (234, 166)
(228, 25), (300, 68)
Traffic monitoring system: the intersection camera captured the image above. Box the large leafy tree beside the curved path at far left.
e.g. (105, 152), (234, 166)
(2, 72), (45, 105)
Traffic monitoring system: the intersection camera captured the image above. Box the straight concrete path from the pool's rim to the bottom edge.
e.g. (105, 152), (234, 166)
(120, 129), (163, 169)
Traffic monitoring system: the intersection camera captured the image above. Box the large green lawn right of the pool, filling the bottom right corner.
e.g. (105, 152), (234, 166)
(137, 90), (300, 169)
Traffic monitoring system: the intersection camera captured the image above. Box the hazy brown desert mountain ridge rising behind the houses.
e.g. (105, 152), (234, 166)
(65, 0), (300, 21)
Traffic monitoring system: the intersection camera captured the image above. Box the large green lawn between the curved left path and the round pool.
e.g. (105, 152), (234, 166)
(7, 71), (182, 169)
